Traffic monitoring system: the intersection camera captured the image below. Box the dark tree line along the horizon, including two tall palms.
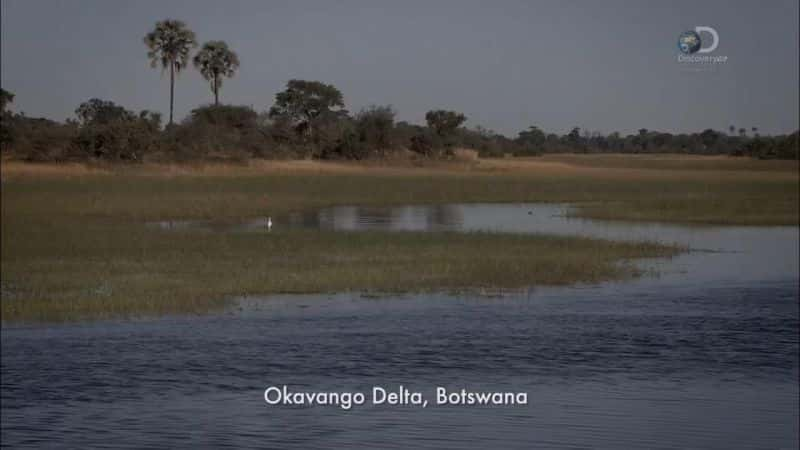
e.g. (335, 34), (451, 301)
(0, 19), (798, 161)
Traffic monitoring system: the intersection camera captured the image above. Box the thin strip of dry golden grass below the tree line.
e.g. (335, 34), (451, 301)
(0, 153), (800, 180)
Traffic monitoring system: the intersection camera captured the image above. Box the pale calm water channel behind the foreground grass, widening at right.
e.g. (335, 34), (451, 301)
(151, 203), (800, 285)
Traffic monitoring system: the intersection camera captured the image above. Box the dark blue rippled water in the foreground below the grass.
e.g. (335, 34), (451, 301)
(2, 205), (800, 449)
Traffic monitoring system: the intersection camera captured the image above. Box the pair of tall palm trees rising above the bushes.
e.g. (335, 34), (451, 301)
(144, 19), (239, 124)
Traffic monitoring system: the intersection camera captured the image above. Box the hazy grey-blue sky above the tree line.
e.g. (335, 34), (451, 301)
(0, 0), (799, 135)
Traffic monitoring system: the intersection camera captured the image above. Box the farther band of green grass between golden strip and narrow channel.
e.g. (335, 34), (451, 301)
(3, 169), (800, 225)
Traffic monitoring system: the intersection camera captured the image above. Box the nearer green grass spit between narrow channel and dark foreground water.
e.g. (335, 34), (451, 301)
(2, 221), (677, 322)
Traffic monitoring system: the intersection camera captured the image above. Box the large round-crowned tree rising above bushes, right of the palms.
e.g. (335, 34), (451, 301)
(269, 80), (347, 136)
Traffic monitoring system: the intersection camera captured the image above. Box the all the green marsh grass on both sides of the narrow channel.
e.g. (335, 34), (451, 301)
(1, 156), (798, 323)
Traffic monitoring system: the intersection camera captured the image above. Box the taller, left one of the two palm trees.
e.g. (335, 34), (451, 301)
(144, 19), (197, 124)
